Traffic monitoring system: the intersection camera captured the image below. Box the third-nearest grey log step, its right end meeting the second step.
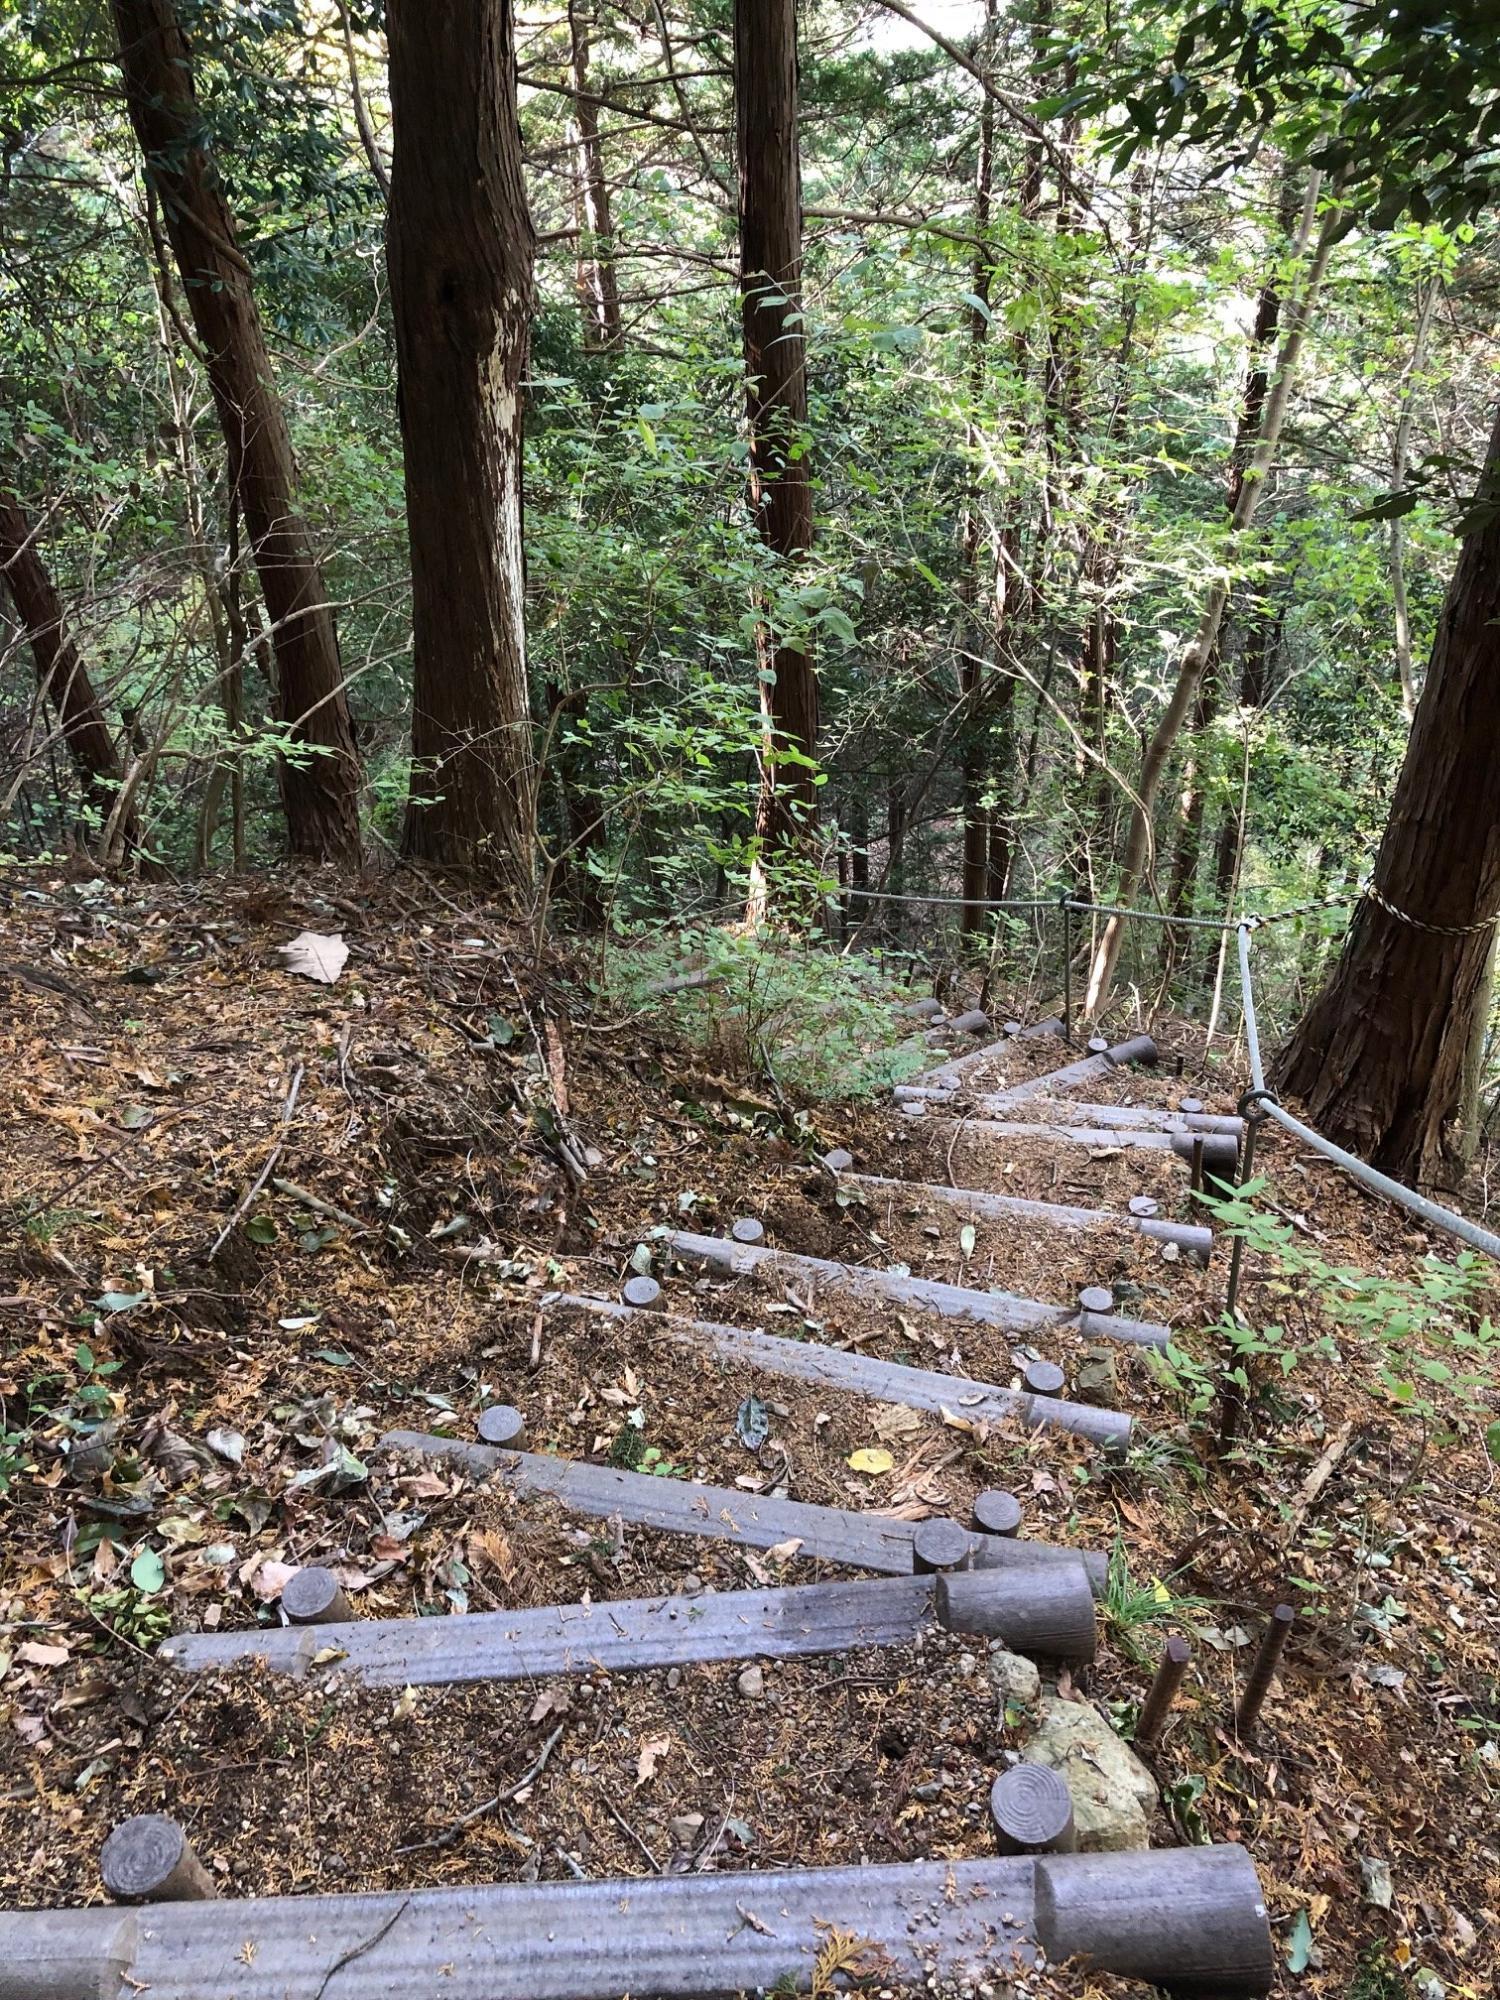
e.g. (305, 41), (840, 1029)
(378, 1430), (1108, 1596)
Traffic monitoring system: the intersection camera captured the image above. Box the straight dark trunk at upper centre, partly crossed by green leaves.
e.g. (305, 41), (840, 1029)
(734, 0), (818, 910)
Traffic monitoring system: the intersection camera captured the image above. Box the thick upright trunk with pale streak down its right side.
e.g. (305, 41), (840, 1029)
(386, 0), (536, 888)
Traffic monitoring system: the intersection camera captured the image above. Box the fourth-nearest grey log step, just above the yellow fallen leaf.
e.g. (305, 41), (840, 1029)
(542, 1292), (1130, 1450)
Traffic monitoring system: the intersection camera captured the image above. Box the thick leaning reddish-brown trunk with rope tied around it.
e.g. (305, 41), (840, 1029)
(1272, 414), (1500, 1184)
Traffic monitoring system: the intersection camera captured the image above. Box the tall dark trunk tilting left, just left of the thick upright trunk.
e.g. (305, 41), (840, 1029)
(114, 0), (360, 860)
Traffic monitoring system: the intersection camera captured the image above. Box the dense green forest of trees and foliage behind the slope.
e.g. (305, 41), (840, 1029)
(0, 0), (1498, 1150)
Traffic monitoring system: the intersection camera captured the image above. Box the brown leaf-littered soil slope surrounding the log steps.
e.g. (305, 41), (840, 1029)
(0, 876), (1500, 2000)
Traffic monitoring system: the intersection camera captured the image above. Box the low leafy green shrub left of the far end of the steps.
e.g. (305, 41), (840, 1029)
(604, 926), (932, 1102)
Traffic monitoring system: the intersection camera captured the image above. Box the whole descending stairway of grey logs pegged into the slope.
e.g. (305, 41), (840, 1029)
(0, 1018), (1272, 2000)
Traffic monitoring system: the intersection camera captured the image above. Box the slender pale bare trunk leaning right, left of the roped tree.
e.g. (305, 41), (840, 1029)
(1084, 174), (1348, 1014)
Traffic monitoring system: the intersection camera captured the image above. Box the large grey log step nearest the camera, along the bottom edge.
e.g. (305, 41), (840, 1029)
(0, 1848), (1274, 2000)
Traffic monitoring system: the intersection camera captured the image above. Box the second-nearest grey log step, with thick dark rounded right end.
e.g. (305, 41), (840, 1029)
(158, 1562), (1096, 1688)
